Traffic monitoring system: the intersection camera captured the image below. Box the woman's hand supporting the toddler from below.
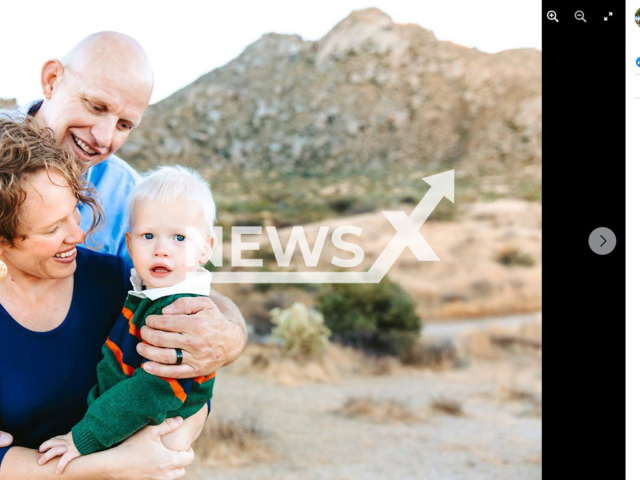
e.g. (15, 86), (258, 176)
(100, 417), (195, 480)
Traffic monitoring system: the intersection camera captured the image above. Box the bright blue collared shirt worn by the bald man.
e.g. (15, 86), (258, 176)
(14, 100), (141, 261)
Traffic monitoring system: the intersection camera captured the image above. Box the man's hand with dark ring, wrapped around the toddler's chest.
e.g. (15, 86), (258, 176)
(137, 292), (247, 378)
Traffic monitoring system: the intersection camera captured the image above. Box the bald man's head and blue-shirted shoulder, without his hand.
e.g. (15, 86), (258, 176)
(34, 32), (153, 258)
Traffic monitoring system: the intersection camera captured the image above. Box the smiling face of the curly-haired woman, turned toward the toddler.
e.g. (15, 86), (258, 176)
(0, 170), (85, 279)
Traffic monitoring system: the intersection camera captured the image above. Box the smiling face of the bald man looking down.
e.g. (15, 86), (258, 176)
(36, 68), (151, 165)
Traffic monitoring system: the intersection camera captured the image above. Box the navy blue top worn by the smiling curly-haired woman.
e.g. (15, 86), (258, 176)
(0, 248), (131, 464)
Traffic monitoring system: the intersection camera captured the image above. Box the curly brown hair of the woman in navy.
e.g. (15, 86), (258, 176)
(0, 116), (104, 247)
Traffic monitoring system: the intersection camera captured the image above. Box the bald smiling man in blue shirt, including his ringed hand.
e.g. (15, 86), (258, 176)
(0, 32), (246, 478)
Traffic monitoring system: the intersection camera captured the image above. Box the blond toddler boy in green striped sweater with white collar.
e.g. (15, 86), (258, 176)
(38, 166), (216, 473)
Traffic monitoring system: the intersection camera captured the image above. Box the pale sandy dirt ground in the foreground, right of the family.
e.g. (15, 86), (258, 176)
(186, 355), (541, 480)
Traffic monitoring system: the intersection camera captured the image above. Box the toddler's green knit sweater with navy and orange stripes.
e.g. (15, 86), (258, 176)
(71, 294), (215, 455)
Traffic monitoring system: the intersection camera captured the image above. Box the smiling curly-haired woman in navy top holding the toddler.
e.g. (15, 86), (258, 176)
(0, 119), (199, 480)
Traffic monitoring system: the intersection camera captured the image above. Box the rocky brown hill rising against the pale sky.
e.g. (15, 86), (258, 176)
(120, 8), (541, 225)
